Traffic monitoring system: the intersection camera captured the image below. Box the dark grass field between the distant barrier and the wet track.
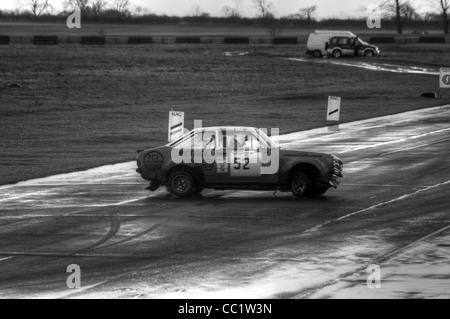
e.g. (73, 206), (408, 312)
(0, 44), (450, 184)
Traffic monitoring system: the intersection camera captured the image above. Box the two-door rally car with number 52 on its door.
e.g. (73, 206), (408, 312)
(136, 127), (343, 197)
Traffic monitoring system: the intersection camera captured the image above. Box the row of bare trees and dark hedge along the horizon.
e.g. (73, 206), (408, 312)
(0, 0), (450, 34)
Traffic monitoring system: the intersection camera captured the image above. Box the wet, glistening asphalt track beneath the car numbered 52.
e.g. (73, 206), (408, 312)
(0, 106), (450, 298)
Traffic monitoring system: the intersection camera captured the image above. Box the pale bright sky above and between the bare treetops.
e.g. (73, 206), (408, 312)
(0, 0), (436, 19)
